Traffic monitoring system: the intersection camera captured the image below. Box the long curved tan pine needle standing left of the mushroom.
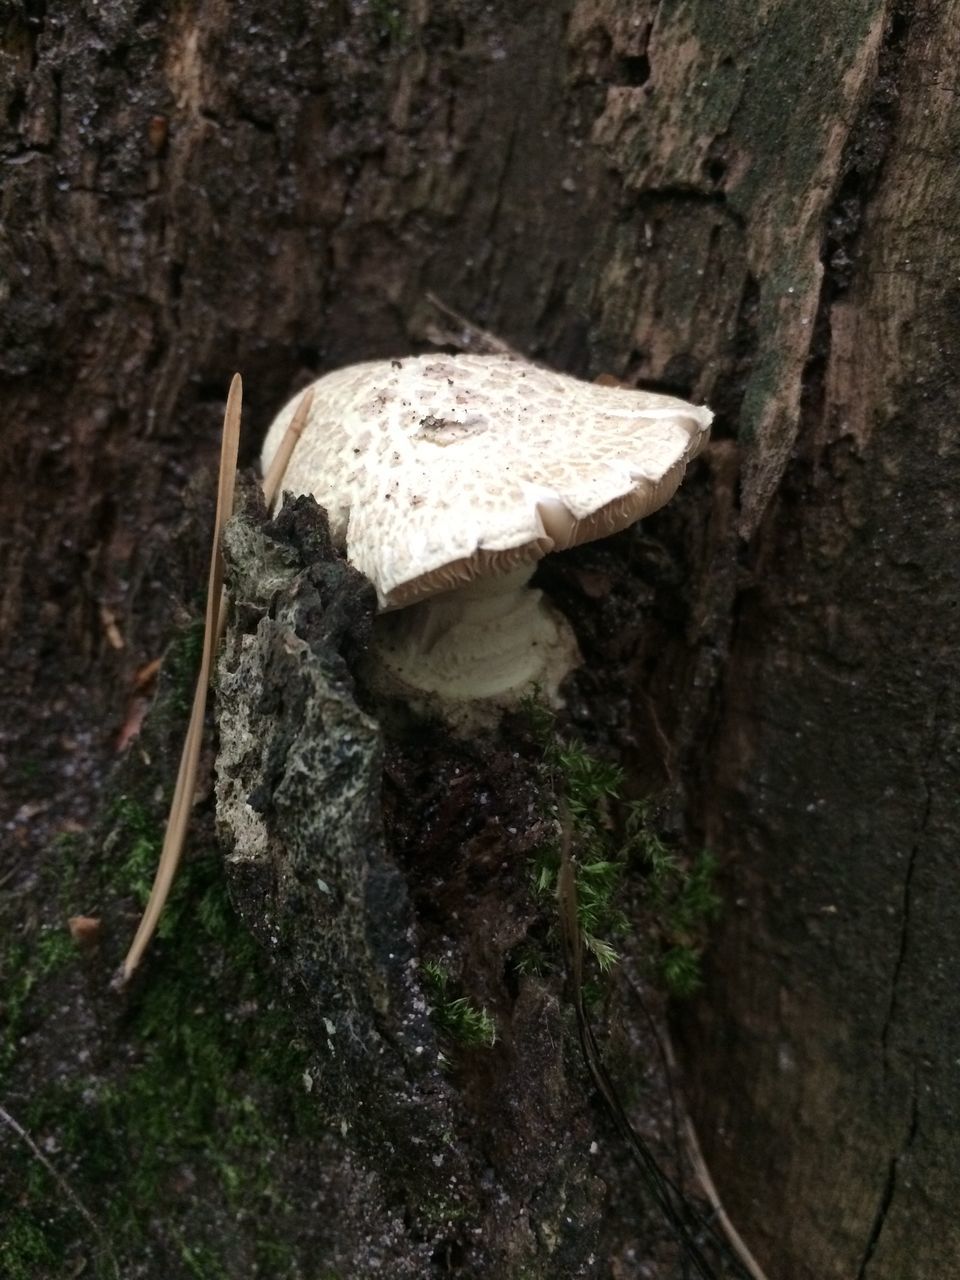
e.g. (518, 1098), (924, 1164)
(114, 374), (243, 987)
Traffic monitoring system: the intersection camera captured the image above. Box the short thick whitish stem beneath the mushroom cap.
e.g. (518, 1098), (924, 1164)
(375, 564), (580, 716)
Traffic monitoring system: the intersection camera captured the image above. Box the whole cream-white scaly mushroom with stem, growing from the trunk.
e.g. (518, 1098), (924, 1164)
(261, 355), (713, 724)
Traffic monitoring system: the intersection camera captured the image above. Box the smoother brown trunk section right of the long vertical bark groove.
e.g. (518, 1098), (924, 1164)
(687, 5), (960, 1280)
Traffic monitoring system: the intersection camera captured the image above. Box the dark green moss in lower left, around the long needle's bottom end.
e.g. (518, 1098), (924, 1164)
(0, 796), (320, 1280)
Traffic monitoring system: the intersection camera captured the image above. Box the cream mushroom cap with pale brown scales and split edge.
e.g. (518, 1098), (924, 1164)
(262, 355), (713, 608)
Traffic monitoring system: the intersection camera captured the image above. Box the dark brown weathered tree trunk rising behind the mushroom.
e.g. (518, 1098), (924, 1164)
(0, 0), (960, 1280)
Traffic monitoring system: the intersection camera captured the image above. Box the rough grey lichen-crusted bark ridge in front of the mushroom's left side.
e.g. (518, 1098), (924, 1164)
(216, 499), (463, 1192)
